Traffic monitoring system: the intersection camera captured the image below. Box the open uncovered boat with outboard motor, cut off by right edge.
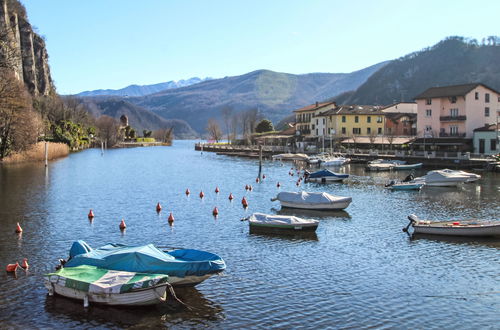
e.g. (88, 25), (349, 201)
(403, 214), (500, 236)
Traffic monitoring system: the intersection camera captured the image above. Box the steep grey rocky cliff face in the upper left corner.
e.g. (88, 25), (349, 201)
(0, 0), (55, 96)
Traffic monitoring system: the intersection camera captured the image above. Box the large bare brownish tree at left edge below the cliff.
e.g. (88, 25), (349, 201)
(0, 69), (41, 159)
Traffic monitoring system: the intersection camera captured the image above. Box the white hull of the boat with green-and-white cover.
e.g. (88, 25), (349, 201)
(45, 280), (167, 306)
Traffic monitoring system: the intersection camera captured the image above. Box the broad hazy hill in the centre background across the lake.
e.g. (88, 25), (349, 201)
(127, 62), (387, 133)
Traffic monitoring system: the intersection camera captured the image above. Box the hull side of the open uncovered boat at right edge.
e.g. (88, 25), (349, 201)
(413, 225), (500, 237)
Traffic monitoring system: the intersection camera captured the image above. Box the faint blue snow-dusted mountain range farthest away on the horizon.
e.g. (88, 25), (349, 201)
(76, 77), (212, 96)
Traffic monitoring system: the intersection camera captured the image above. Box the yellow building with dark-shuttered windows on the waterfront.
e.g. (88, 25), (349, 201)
(320, 105), (385, 138)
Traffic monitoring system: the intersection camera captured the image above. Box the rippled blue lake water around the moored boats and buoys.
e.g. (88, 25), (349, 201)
(0, 141), (500, 329)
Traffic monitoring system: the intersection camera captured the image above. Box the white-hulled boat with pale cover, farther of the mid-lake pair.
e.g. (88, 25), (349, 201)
(271, 191), (352, 210)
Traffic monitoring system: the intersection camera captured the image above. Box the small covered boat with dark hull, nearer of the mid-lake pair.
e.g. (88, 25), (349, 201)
(248, 213), (319, 233)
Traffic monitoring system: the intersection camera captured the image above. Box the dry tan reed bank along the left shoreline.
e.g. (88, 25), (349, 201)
(2, 142), (69, 164)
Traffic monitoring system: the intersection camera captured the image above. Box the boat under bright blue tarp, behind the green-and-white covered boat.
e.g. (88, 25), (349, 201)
(64, 241), (226, 286)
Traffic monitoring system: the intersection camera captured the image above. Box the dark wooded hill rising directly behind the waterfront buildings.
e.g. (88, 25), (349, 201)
(332, 37), (500, 105)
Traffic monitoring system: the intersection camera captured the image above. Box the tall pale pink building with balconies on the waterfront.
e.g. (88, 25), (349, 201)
(415, 83), (500, 139)
